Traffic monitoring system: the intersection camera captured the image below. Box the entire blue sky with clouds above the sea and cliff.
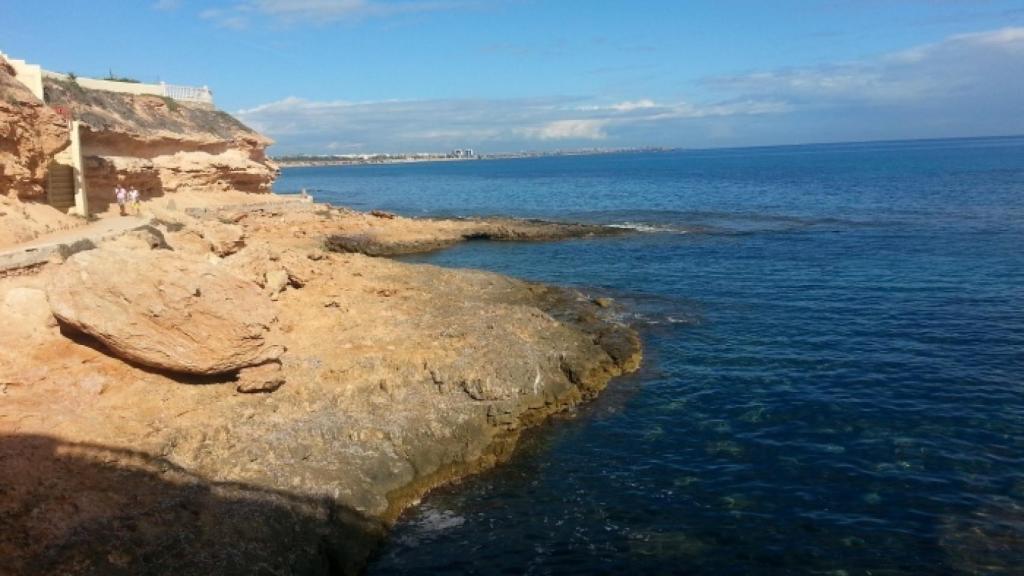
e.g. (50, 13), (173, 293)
(6, 0), (1024, 156)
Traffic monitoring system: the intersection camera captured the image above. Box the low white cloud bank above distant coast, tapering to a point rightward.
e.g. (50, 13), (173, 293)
(237, 91), (781, 152)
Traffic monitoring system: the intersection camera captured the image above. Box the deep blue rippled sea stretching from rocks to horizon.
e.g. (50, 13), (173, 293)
(278, 138), (1024, 575)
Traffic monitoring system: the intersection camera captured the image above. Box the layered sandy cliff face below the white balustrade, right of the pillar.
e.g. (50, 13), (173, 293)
(44, 78), (278, 210)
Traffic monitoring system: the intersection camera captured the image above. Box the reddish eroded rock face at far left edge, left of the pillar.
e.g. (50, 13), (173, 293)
(0, 58), (71, 200)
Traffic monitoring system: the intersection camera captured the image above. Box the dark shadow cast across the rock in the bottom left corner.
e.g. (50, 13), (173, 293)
(0, 436), (383, 576)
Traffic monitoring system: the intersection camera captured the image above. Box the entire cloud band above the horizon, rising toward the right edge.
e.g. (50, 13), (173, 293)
(239, 28), (1024, 154)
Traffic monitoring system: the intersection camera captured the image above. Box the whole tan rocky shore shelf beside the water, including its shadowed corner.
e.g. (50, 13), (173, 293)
(0, 196), (641, 574)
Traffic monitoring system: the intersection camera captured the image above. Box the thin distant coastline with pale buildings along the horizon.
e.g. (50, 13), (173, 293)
(271, 148), (679, 168)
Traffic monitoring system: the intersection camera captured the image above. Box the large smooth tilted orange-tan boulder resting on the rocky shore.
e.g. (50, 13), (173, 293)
(46, 245), (283, 375)
